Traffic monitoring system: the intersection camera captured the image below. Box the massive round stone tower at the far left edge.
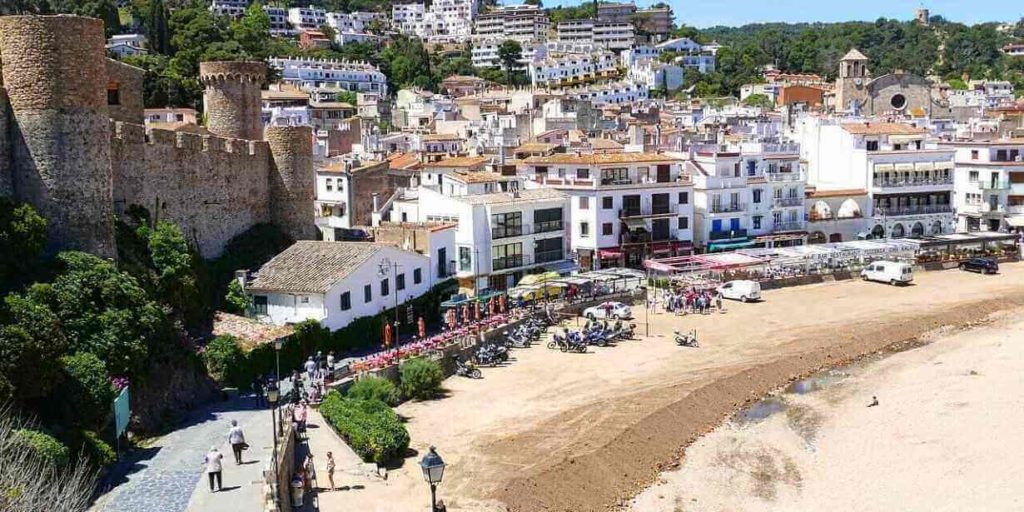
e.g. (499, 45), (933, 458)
(0, 15), (117, 258)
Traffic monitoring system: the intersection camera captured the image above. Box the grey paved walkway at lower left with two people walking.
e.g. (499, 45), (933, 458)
(90, 381), (291, 512)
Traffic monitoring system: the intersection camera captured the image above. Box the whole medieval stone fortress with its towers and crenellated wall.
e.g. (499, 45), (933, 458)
(0, 15), (315, 258)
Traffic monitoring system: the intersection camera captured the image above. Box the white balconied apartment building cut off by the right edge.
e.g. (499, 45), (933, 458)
(940, 140), (1024, 231)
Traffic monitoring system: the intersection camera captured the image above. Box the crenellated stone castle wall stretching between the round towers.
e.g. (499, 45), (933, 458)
(110, 122), (272, 258)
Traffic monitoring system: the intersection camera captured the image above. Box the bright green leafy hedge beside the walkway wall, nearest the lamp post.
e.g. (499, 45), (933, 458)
(319, 390), (410, 464)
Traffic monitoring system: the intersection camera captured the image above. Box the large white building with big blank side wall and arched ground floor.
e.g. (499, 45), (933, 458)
(796, 117), (956, 239)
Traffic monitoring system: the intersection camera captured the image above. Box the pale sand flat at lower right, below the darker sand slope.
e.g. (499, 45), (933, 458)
(632, 310), (1024, 512)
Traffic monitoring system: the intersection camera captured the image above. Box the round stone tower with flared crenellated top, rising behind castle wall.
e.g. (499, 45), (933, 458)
(199, 61), (266, 140)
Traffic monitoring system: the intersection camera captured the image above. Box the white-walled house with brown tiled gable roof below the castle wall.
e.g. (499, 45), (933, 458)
(246, 241), (436, 331)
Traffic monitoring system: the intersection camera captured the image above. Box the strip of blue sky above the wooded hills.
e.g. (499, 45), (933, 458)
(540, 0), (1024, 27)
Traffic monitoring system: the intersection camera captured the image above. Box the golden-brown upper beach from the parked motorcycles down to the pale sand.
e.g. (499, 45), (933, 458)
(323, 264), (1024, 512)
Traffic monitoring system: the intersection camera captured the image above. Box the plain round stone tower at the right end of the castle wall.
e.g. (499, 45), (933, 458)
(266, 126), (316, 240)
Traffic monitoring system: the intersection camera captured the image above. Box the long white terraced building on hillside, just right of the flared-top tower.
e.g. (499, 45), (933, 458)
(267, 57), (387, 94)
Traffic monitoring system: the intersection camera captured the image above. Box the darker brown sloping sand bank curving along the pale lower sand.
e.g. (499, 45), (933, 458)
(487, 294), (1024, 512)
